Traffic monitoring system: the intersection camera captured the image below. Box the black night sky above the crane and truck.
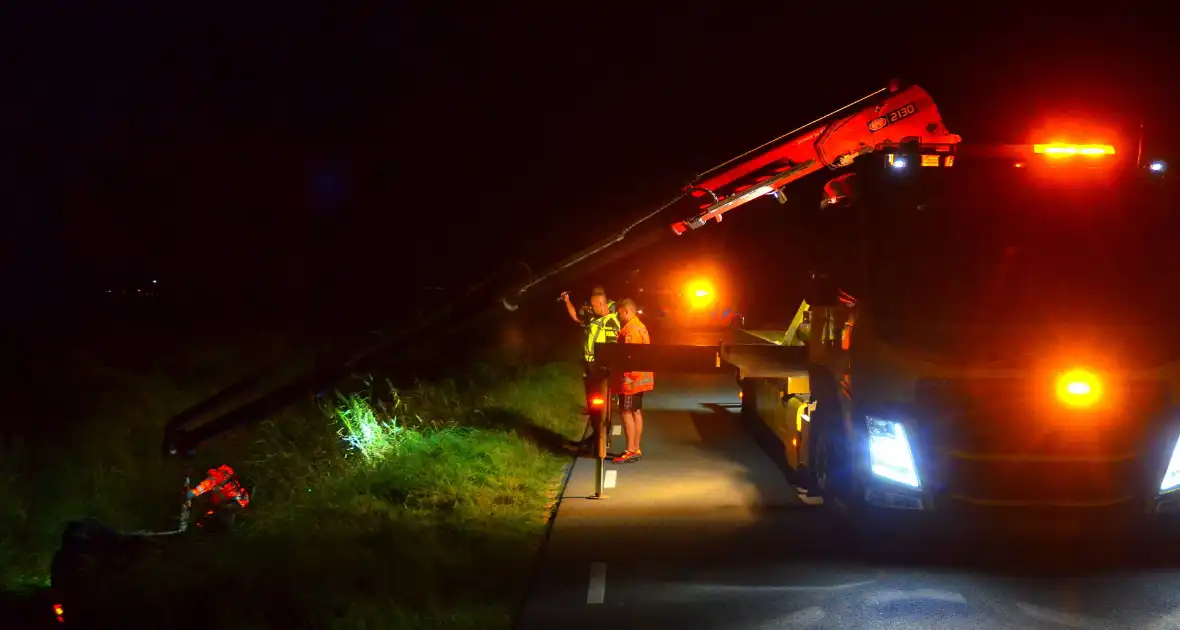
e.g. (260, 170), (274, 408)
(0, 1), (1178, 318)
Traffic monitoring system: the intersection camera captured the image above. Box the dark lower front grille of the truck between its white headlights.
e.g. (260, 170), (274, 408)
(915, 379), (1169, 506)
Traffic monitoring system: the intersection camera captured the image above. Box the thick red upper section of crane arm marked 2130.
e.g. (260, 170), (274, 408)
(671, 85), (961, 235)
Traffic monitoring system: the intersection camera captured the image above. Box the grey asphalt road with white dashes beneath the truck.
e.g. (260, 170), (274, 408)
(520, 374), (1180, 630)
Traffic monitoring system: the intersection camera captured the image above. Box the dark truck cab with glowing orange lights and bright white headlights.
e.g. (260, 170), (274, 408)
(739, 144), (1180, 530)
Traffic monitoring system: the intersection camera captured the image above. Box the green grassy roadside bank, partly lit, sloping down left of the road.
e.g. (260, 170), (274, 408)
(0, 335), (582, 629)
